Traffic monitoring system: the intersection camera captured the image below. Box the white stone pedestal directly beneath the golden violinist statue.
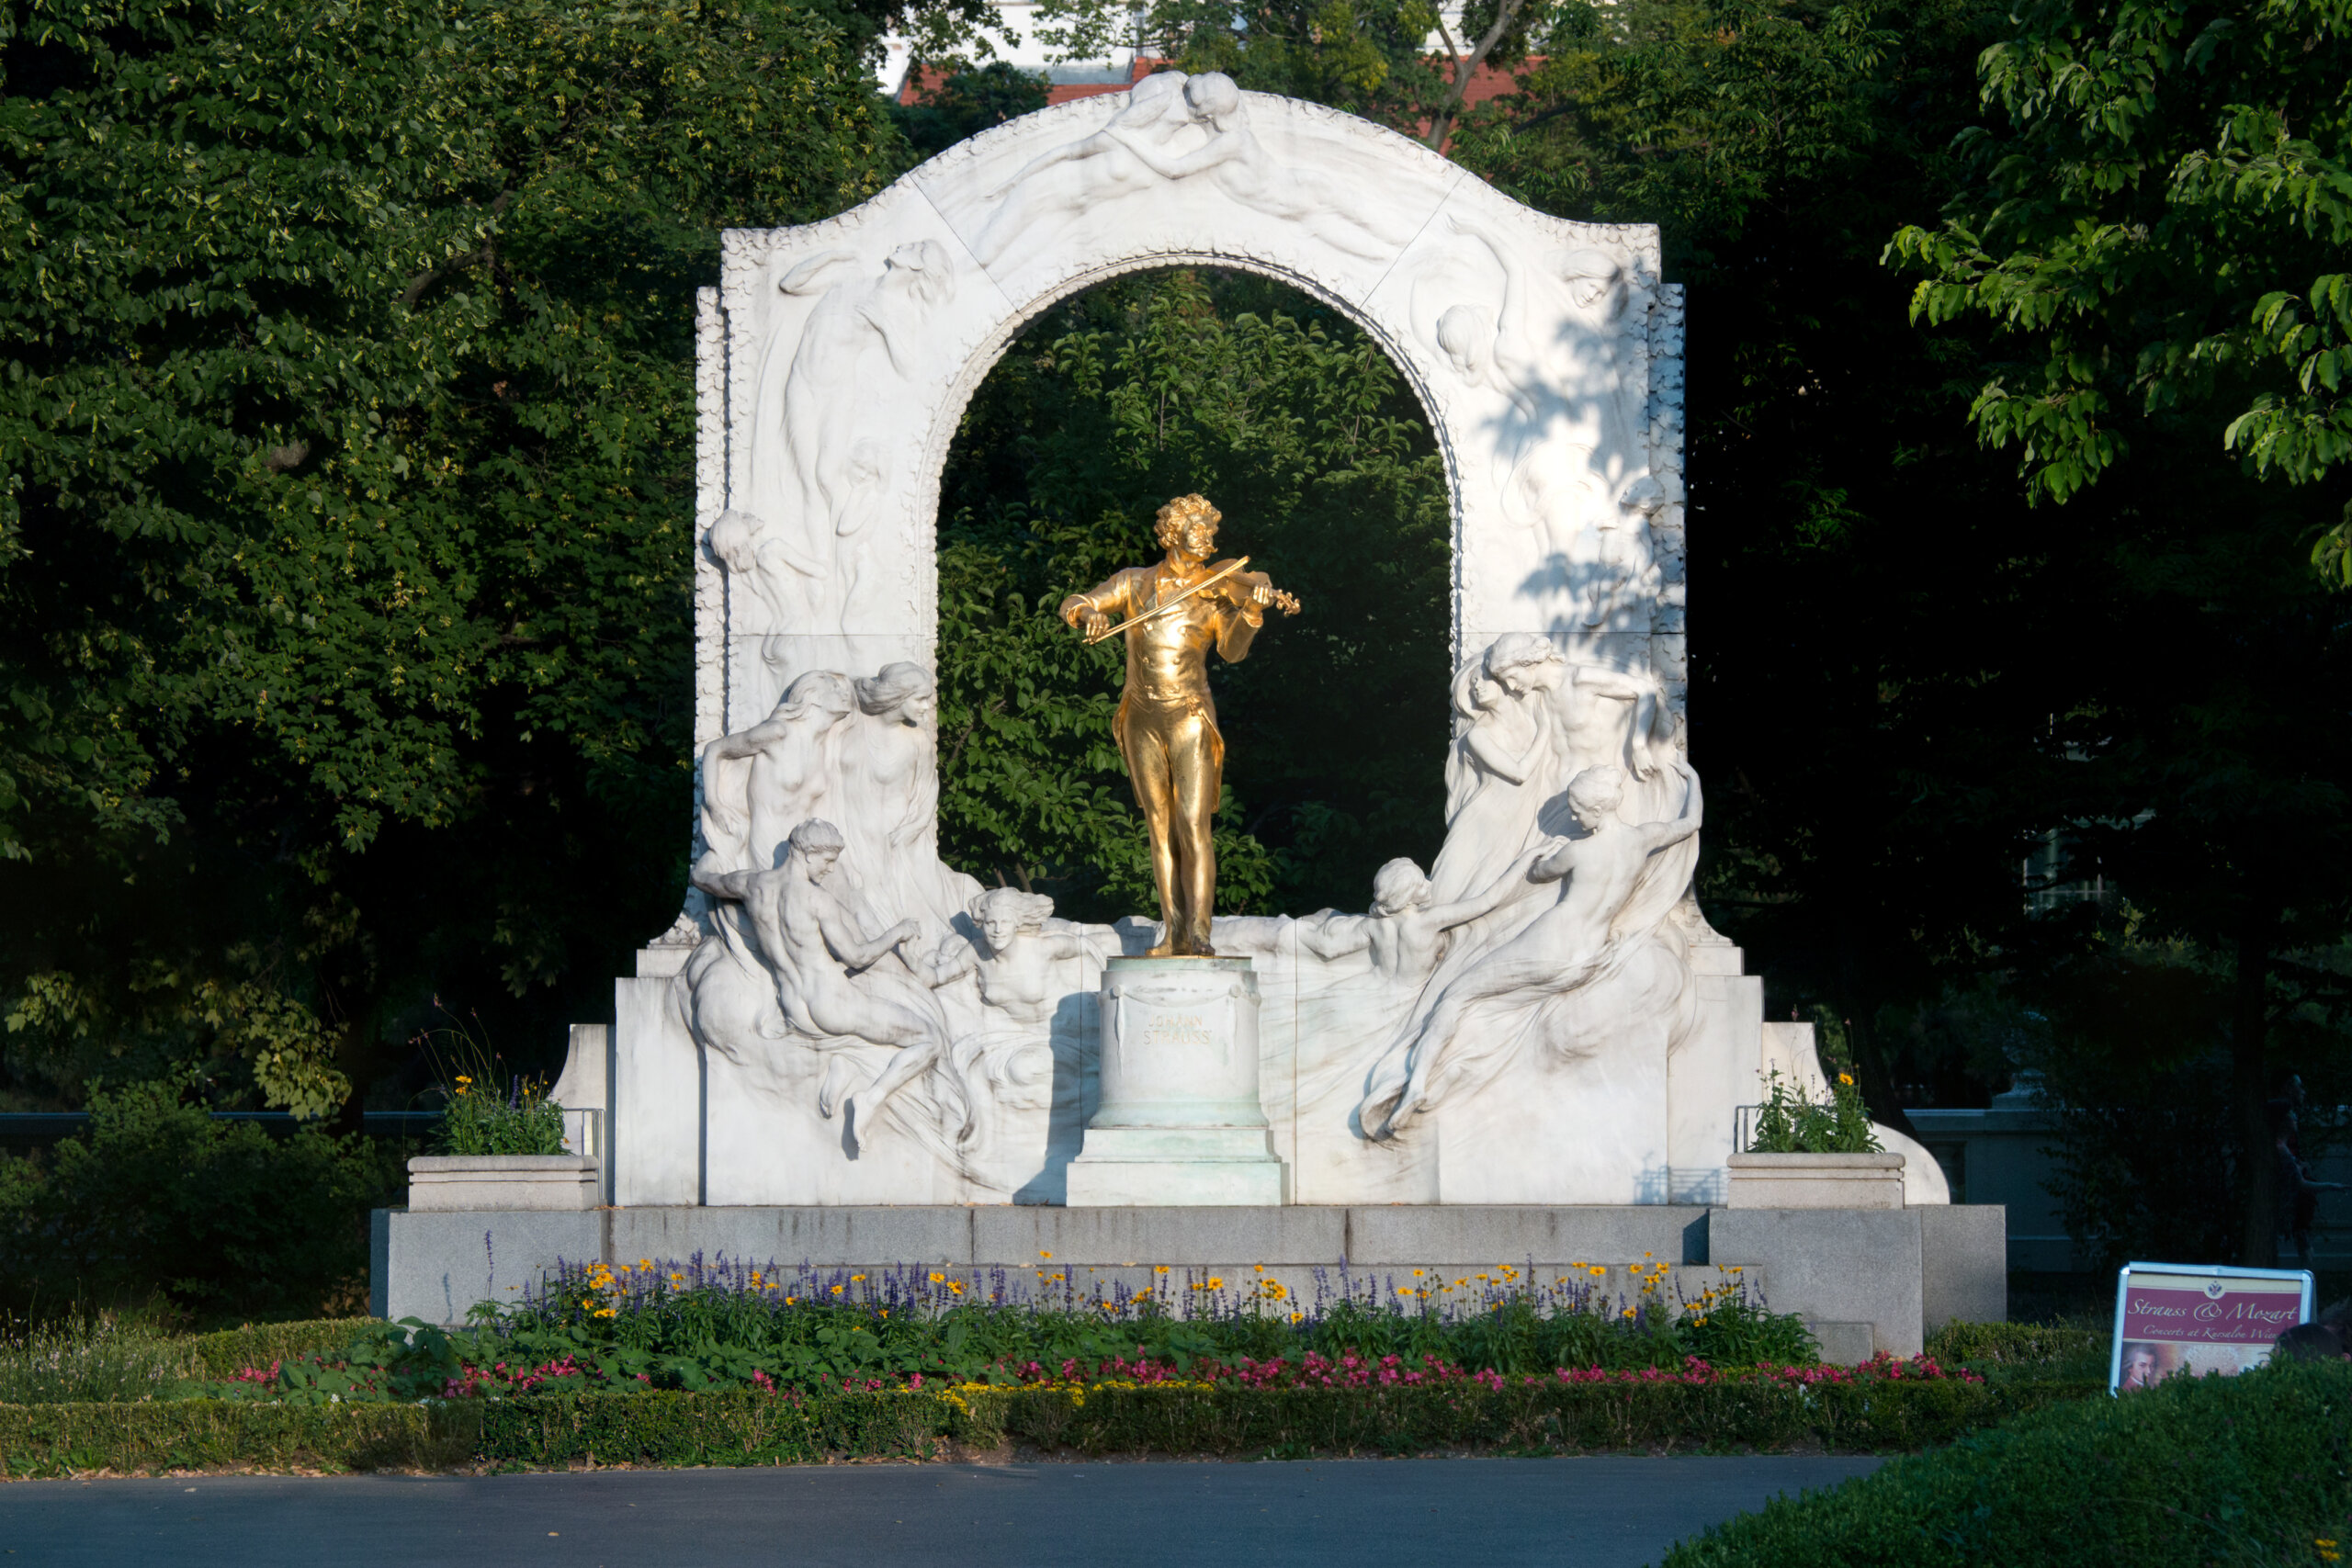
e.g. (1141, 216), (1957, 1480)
(1068, 959), (1289, 1208)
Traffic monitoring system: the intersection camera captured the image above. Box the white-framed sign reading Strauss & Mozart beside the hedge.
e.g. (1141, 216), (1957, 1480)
(2108, 1262), (2312, 1394)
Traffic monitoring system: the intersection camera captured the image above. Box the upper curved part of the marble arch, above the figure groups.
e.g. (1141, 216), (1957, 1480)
(696, 73), (1684, 748)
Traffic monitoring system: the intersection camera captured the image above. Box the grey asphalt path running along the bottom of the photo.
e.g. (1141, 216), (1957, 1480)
(0, 1455), (1877, 1568)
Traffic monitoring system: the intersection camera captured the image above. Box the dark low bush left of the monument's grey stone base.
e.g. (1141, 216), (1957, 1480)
(0, 1081), (404, 1319)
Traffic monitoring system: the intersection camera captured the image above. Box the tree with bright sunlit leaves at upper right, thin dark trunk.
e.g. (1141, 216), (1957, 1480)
(1891, 0), (2352, 1260)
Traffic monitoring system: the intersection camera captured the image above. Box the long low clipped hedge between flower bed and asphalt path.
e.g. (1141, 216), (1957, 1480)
(0, 1382), (2084, 1476)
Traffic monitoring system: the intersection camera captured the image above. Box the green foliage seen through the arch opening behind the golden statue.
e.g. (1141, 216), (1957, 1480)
(938, 273), (1452, 919)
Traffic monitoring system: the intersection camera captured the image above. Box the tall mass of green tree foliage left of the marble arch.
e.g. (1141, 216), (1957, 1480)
(0, 0), (903, 1112)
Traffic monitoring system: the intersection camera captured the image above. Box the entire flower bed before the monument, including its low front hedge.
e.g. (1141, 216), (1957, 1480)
(0, 1260), (2100, 1476)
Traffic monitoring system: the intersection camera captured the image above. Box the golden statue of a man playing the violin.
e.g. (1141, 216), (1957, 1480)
(1061, 496), (1298, 959)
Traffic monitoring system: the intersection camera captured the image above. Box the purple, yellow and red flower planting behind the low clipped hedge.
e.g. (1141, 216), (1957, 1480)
(211, 1262), (1815, 1401)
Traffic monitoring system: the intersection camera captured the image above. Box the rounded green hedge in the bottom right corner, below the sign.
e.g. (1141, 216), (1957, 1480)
(1665, 1363), (2352, 1568)
